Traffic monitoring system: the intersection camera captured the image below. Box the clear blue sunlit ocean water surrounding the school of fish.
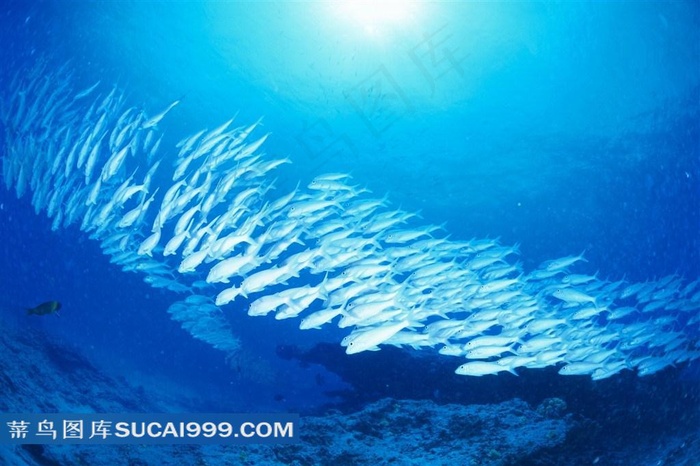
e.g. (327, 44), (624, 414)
(0, 1), (700, 464)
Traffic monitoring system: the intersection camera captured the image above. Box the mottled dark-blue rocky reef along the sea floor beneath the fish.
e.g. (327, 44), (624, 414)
(0, 320), (700, 466)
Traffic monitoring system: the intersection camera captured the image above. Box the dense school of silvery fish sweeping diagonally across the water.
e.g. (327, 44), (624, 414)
(0, 59), (700, 380)
